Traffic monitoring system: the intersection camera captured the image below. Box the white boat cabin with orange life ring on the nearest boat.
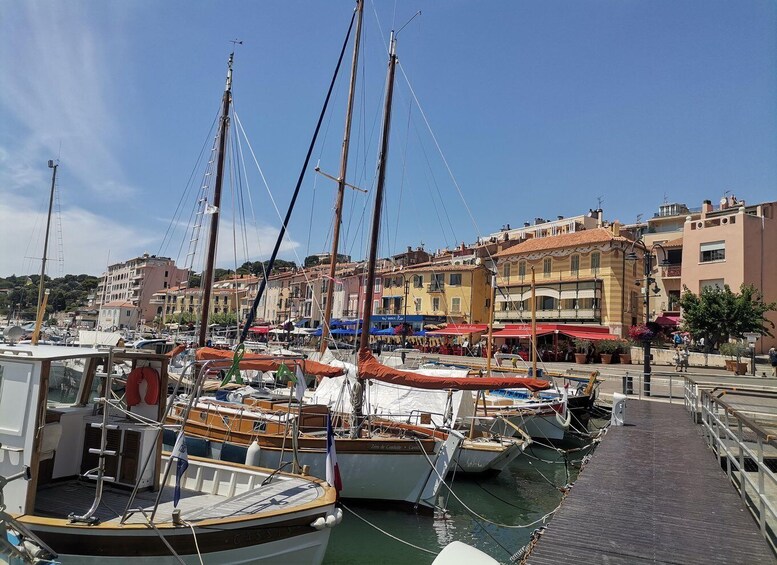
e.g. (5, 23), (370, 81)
(0, 345), (169, 514)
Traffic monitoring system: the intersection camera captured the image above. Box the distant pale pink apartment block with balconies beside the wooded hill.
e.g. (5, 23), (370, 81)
(95, 253), (189, 327)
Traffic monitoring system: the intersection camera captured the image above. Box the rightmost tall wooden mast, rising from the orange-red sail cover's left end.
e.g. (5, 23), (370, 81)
(359, 31), (397, 350)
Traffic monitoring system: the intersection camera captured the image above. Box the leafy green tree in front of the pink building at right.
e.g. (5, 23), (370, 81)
(680, 284), (777, 349)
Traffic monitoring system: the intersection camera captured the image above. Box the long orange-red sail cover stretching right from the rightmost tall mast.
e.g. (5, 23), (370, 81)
(359, 349), (550, 390)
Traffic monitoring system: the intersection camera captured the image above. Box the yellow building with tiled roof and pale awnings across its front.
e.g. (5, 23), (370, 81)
(494, 224), (643, 337)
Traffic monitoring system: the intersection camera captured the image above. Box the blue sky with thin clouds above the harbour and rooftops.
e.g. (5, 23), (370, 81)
(0, 0), (777, 276)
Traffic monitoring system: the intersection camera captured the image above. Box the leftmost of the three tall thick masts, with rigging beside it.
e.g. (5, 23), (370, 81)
(199, 52), (235, 347)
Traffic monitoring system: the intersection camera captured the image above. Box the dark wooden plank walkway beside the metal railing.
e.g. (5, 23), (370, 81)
(528, 399), (777, 565)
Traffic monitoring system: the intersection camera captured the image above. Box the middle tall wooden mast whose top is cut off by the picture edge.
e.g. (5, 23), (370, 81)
(321, 0), (364, 353)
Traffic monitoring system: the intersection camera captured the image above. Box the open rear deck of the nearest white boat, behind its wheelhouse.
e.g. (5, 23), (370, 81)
(35, 478), (324, 524)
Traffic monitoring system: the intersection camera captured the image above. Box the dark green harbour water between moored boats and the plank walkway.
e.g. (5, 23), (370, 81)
(324, 446), (596, 565)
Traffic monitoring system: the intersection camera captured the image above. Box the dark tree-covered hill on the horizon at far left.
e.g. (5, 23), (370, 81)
(0, 275), (100, 320)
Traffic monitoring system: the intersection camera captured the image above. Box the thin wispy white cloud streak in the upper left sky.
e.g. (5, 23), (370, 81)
(0, 1), (136, 196)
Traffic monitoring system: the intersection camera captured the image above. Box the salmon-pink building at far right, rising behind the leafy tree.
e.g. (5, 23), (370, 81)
(682, 197), (777, 354)
